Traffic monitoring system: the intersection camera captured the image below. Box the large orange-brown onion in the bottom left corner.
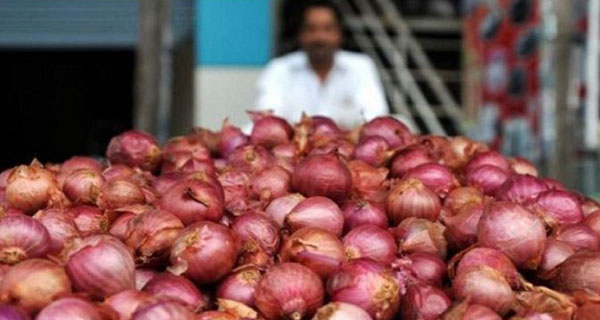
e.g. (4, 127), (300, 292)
(0, 259), (71, 313)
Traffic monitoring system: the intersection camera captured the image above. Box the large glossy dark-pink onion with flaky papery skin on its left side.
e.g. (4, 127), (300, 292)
(170, 221), (237, 284)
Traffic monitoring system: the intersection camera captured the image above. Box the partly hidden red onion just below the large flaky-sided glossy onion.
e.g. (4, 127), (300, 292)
(143, 273), (207, 312)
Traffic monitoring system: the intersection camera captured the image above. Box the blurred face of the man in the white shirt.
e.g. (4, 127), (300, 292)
(299, 7), (342, 63)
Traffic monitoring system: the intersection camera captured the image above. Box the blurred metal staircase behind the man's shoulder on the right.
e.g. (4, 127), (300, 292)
(336, 0), (466, 135)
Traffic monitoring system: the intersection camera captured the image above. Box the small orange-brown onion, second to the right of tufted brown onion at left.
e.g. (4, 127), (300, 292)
(98, 180), (146, 209)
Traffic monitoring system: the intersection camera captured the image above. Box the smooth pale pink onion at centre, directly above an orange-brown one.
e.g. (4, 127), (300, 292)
(285, 197), (344, 236)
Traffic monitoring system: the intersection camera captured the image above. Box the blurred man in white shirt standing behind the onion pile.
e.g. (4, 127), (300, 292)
(256, 0), (388, 128)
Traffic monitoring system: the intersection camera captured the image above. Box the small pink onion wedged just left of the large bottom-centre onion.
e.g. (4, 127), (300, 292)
(217, 266), (262, 307)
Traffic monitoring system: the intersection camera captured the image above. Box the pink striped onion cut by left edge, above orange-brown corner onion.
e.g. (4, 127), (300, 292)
(0, 215), (51, 264)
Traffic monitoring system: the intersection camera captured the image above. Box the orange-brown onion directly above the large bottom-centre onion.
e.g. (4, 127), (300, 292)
(279, 227), (345, 279)
